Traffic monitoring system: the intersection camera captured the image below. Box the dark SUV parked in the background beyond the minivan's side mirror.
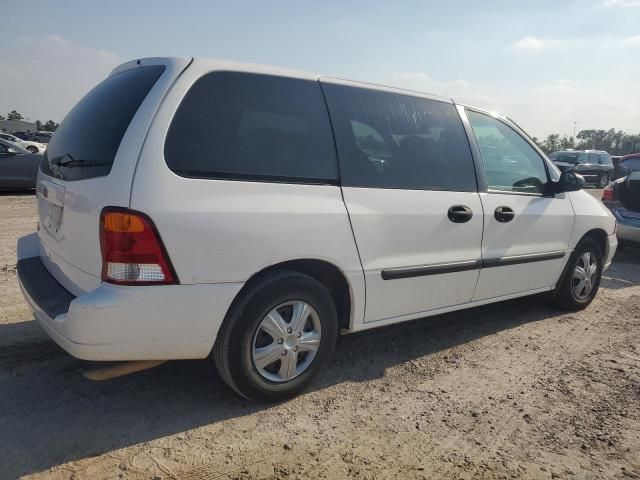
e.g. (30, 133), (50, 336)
(549, 150), (614, 188)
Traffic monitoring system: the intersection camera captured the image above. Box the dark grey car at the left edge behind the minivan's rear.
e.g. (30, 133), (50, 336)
(0, 139), (42, 190)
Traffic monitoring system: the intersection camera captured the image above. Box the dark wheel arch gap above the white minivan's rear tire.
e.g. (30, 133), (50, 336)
(228, 258), (353, 330)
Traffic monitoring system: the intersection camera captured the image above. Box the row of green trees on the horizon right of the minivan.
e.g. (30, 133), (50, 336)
(533, 128), (640, 155)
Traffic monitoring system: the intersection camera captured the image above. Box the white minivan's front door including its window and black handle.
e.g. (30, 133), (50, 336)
(466, 109), (574, 301)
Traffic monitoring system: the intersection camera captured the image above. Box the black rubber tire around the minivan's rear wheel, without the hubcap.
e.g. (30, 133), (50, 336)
(212, 271), (338, 402)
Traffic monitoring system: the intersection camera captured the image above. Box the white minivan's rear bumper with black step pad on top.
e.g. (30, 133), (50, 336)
(18, 248), (242, 361)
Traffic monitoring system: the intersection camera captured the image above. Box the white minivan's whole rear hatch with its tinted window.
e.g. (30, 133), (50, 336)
(36, 59), (191, 295)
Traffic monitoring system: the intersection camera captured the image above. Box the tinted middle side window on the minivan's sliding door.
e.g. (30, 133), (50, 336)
(323, 84), (476, 191)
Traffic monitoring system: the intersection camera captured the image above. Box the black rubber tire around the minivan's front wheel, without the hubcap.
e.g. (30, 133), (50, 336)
(554, 237), (603, 311)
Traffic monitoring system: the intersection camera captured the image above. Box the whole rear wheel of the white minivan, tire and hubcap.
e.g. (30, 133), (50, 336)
(213, 271), (338, 402)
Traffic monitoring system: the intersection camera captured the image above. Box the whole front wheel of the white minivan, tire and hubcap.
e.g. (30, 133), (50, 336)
(555, 237), (603, 310)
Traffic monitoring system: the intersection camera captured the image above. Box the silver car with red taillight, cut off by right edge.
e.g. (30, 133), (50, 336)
(602, 172), (640, 247)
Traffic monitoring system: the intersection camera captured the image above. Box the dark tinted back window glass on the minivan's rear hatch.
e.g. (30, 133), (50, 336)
(42, 65), (164, 180)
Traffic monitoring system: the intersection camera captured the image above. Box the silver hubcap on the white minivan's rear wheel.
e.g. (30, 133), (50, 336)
(251, 301), (321, 382)
